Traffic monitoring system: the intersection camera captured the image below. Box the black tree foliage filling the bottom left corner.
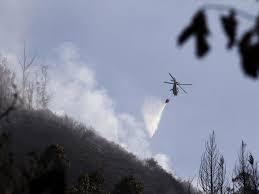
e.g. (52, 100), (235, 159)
(0, 133), (69, 194)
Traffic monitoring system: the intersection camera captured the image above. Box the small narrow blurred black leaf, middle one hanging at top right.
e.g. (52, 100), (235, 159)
(220, 10), (238, 49)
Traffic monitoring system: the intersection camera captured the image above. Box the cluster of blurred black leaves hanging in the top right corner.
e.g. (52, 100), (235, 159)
(178, 9), (259, 78)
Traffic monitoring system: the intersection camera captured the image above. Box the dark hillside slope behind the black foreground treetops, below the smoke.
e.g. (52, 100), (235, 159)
(1, 107), (202, 194)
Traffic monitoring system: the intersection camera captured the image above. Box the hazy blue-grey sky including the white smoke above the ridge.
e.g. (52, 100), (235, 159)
(0, 0), (259, 181)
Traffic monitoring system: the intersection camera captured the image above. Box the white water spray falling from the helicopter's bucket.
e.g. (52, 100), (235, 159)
(142, 97), (166, 137)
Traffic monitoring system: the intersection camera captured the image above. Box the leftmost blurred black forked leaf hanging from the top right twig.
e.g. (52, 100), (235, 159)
(178, 10), (210, 58)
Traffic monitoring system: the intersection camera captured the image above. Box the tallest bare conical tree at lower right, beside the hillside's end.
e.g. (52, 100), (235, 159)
(199, 131), (226, 194)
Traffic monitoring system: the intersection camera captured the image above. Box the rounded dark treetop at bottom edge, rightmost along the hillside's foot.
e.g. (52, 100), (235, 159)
(112, 176), (144, 194)
